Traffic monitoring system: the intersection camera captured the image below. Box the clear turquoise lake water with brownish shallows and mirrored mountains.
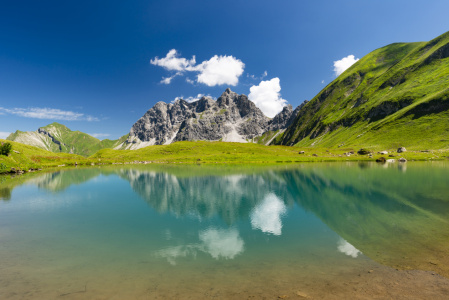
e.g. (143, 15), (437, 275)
(0, 163), (449, 299)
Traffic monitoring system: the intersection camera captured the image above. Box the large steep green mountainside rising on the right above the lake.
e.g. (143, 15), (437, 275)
(274, 32), (449, 149)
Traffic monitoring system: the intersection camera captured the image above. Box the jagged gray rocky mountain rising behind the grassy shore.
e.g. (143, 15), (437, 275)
(121, 89), (297, 149)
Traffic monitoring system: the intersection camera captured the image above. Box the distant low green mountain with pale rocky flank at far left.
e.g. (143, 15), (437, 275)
(7, 122), (127, 156)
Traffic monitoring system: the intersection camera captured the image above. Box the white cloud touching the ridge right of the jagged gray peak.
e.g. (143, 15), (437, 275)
(248, 77), (287, 118)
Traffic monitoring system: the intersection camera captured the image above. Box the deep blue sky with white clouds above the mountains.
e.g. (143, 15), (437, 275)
(0, 0), (449, 139)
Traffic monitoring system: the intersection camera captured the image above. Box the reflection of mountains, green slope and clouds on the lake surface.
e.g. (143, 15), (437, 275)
(0, 162), (449, 276)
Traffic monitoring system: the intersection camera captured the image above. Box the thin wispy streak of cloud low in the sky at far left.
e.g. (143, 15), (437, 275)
(0, 107), (98, 121)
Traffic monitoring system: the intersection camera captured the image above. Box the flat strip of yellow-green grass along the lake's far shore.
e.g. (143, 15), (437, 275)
(0, 140), (449, 174)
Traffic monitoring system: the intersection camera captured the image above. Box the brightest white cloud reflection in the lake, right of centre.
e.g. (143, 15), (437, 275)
(250, 193), (287, 235)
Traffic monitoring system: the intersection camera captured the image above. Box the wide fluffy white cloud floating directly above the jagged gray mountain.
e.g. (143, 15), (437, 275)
(150, 49), (245, 86)
